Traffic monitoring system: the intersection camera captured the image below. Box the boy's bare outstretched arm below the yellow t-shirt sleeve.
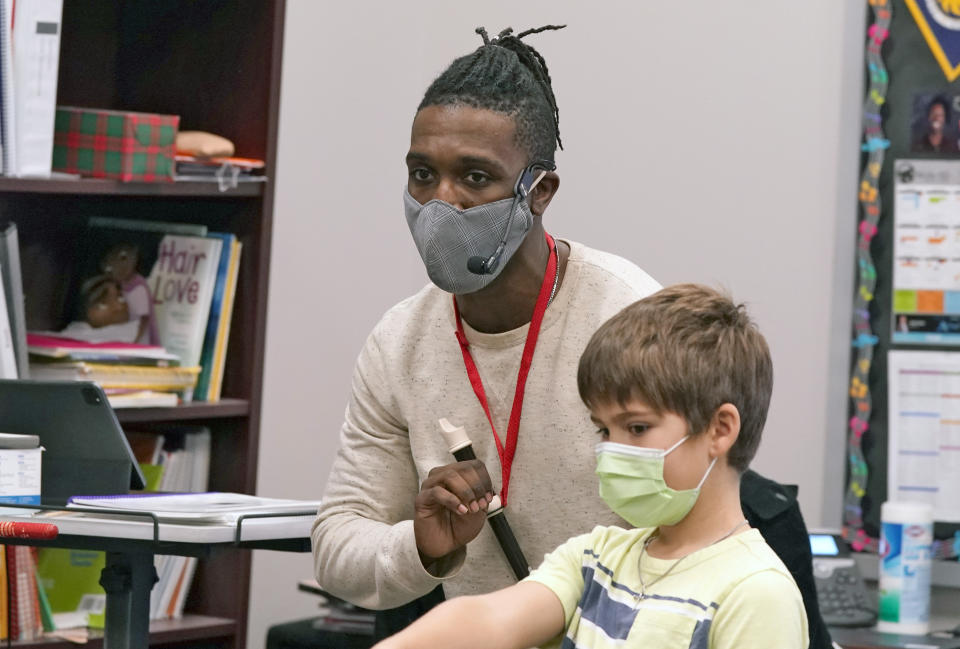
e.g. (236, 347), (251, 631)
(374, 581), (565, 649)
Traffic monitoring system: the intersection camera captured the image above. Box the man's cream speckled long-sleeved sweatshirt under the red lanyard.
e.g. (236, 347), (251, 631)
(311, 241), (660, 609)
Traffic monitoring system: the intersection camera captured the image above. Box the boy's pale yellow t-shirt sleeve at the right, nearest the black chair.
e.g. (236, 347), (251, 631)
(710, 570), (809, 649)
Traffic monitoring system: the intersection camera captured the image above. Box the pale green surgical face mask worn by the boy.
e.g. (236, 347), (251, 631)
(597, 435), (717, 527)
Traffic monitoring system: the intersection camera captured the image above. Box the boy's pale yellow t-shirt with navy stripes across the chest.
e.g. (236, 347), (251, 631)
(527, 527), (808, 649)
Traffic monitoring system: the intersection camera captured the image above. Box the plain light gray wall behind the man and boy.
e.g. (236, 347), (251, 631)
(249, 0), (866, 648)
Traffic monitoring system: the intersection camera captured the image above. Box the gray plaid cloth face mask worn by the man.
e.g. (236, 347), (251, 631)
(403, 187), (533, 295)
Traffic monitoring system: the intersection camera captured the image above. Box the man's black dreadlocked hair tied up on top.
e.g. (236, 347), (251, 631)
(417, 25), (566, 162)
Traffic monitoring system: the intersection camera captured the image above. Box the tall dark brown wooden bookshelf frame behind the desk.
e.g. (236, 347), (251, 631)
(0, 0), (284, 649)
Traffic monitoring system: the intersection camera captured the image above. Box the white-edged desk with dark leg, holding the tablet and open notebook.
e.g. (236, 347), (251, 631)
(0, 503), (316, 649)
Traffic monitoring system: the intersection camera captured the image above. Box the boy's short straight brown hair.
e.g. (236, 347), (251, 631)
(577, 284), (773, 473)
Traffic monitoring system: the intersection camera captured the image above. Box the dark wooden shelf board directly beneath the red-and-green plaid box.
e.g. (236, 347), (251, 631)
(0, 178), (269, 198)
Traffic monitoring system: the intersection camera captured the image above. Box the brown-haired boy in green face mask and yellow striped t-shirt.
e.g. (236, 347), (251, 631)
(378, 284), (807, 649)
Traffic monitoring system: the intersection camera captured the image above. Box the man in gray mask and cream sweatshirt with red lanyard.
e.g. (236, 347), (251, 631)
(312, 27), (659, 609)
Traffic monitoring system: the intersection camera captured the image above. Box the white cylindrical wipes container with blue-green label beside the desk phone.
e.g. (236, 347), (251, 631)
(877, 502), (933, 634)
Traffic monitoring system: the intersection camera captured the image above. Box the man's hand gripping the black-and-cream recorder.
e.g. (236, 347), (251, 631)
(413, 460), (493, 566)
